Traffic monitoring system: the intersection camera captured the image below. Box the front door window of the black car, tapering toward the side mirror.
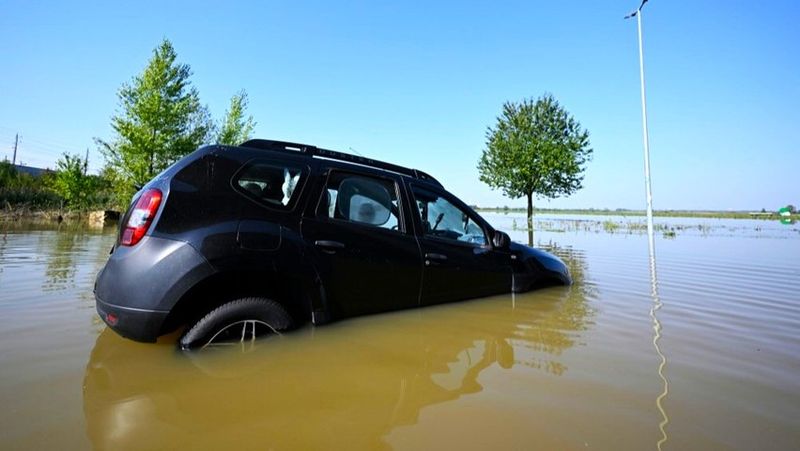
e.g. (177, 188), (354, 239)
(412, 186), (489, 246)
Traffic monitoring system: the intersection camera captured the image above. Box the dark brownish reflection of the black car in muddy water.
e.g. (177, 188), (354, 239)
(83, 288), (591, 449)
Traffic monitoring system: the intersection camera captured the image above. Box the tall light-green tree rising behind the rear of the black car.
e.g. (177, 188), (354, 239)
(96, 39), (213, 206)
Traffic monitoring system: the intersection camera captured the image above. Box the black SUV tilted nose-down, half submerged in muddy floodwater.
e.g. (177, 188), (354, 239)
(95, 139), (571, 349)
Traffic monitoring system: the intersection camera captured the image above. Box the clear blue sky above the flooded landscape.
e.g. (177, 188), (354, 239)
(0, 0), (800, 210)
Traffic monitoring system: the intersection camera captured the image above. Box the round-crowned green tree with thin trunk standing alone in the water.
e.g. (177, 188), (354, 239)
(478, 94), (592, 244)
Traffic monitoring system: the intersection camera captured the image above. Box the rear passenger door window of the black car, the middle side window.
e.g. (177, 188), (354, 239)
(317, 172), (400, 230)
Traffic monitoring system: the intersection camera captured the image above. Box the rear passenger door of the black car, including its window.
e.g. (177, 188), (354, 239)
(301, 170), (422, 317)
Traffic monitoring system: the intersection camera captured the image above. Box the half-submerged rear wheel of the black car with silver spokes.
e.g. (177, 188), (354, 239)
(178, 297), (294, 350)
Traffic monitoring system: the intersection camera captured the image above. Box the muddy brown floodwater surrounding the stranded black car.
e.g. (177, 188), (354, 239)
(0, 214), (800, 450)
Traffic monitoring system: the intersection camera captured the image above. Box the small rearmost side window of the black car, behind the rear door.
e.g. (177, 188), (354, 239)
(233, 162), (303, 208)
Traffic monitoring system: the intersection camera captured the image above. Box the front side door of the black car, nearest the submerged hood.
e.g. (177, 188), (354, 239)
(411, 185), (511, 305)
